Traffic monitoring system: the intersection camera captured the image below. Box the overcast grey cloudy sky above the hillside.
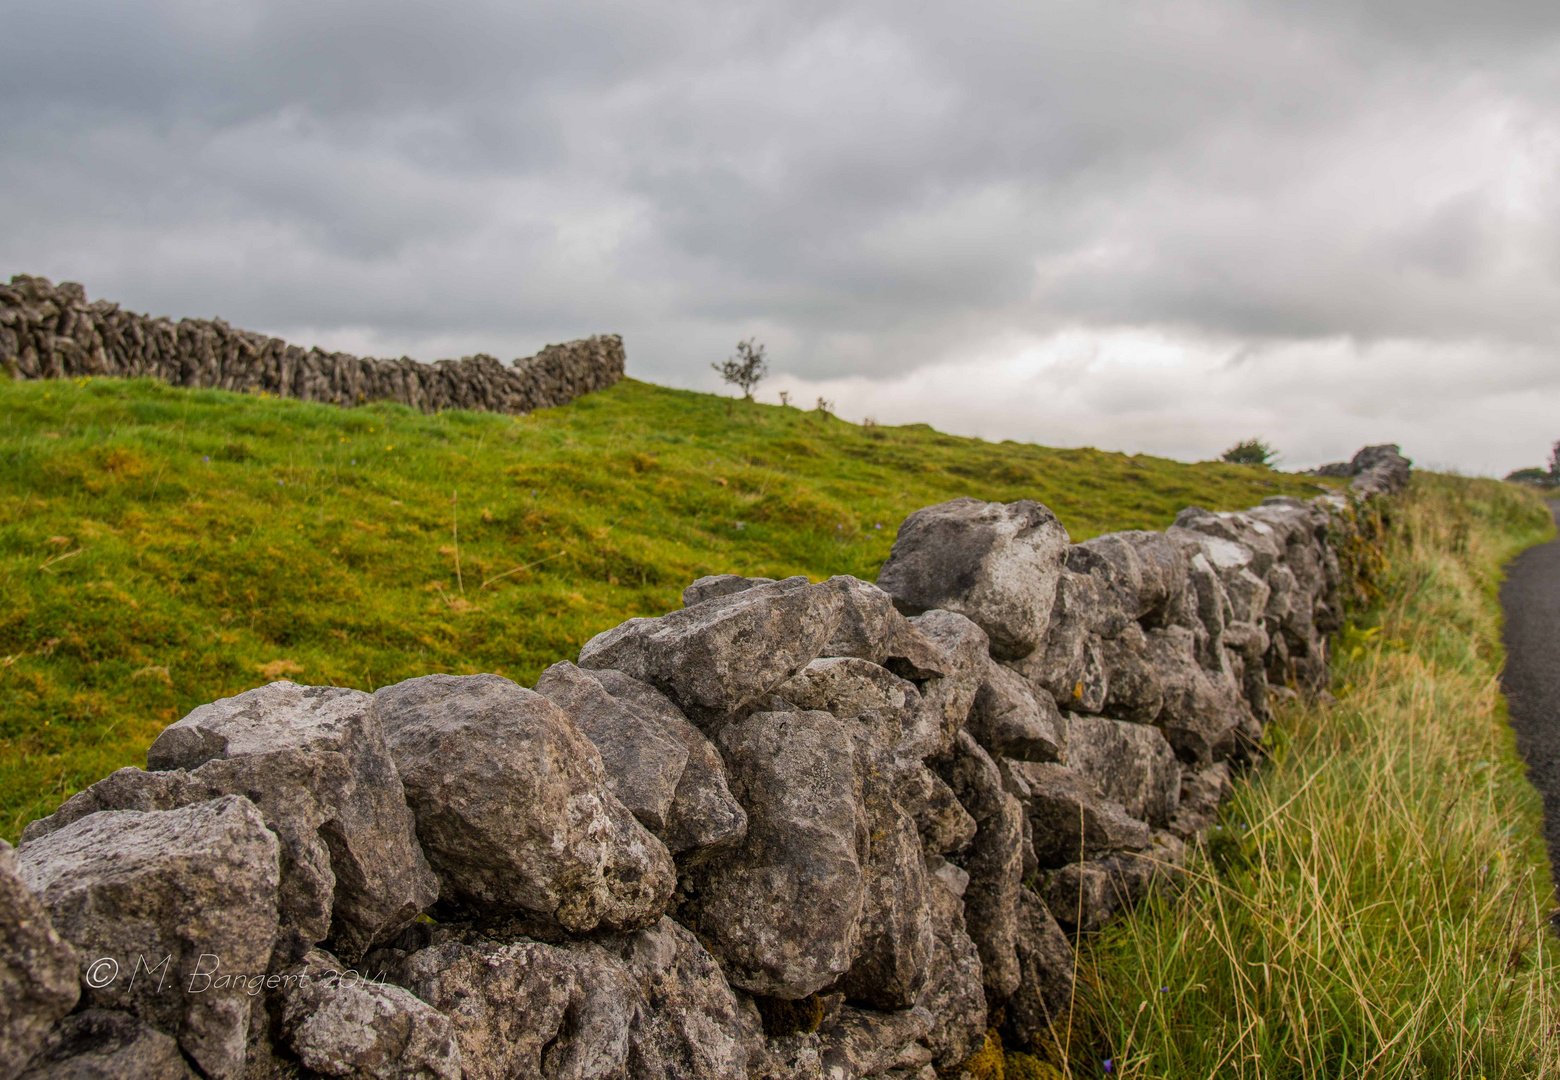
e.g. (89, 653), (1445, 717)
(0, 0), (1560, 473)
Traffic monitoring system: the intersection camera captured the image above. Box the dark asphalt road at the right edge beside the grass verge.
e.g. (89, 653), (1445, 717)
(1501, 501), (1560, 871)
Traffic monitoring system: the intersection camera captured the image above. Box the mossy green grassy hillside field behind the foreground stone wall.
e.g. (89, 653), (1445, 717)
(0, 379), (1341, 840)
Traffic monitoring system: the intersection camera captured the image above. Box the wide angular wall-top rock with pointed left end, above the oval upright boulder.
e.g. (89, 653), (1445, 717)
(579, 579), (844, 729)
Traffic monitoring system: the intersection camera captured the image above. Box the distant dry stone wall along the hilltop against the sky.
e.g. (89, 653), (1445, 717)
(0, 275), (624, 414)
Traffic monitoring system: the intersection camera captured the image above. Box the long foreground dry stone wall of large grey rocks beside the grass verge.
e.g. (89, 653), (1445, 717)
(0, 446), (1409, 1080)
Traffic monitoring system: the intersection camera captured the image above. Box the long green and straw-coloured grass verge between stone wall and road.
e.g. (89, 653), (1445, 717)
(1075, 473), (1560, 1080)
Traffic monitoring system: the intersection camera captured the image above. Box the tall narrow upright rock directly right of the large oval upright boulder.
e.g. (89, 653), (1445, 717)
(824, 740), (934, 1011)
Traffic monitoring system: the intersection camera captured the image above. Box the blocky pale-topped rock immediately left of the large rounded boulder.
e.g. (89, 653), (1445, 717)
(25, 682), (438, 960)
